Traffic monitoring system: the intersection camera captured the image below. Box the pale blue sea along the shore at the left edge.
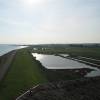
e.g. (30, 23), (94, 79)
(0, 44), (26, 56)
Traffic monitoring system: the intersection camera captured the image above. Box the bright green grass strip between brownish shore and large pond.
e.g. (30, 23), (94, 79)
(0, 49), (47, 100)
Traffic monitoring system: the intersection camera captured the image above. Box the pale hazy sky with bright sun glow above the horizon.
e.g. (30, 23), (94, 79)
(0, 0), (100, 44)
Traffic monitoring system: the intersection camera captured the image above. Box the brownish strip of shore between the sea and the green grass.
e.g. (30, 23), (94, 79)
(0, 50), (16, 81)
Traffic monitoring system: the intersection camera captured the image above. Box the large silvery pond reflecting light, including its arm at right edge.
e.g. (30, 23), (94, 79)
(32, 53), (100, 77)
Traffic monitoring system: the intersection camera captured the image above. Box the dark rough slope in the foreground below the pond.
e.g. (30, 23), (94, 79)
(16, 77), (100, 100)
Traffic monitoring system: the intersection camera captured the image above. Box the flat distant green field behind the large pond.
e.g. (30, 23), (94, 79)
(33, 47), (100, 59)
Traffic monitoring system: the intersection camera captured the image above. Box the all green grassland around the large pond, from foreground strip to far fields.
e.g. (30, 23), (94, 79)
(0, 45), (100, 100)
